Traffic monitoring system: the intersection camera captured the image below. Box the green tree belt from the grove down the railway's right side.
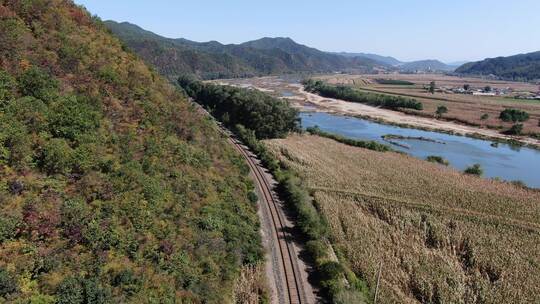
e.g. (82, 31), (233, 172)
(178, 76), (370, 304)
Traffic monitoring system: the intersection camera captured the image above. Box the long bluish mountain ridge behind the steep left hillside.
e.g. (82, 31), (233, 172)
(105, 21), (381, 79)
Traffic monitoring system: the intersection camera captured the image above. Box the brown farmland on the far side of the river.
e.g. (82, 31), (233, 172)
(317, 74), (540, 133)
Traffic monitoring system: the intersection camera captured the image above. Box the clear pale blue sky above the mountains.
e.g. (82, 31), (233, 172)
(75, 0), (540, 62)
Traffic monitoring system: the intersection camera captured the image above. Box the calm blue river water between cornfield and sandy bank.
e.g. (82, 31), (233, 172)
(300, 112), (540, 188)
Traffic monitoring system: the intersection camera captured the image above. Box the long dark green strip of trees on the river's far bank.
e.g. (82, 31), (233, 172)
(303, 79), (423, 110)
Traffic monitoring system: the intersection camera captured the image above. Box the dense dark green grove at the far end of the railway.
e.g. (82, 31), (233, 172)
(178, 76), (299, 139)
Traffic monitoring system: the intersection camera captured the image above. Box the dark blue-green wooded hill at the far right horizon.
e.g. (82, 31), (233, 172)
(456, 51), (540, 81)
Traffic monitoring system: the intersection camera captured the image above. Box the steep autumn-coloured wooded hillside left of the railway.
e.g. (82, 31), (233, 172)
(0, 0), (262, 303)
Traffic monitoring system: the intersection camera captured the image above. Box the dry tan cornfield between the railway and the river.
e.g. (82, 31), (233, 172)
(265, 135), (540, 303)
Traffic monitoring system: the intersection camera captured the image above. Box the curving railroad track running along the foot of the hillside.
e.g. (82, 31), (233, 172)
(226, 137), (307, 304)
